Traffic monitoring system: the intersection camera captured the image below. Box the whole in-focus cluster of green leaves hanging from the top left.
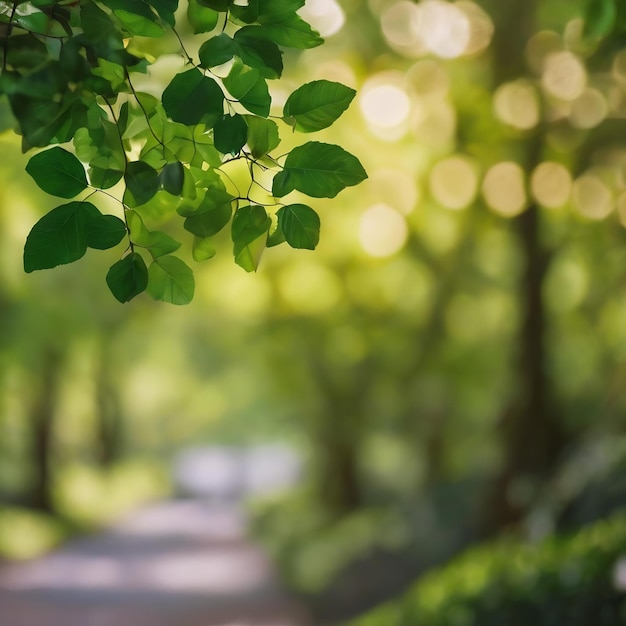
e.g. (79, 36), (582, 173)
(0, 0), (366, 304)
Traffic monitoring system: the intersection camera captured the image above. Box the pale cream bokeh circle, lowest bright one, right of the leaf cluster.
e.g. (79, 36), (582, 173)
(359, 203), (409, 257)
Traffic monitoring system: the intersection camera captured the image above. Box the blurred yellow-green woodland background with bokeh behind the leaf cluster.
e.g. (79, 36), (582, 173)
(0, 0), (626, 626)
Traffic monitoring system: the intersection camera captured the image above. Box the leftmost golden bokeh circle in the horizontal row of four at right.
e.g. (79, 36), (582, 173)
(429, 156), (478, 210)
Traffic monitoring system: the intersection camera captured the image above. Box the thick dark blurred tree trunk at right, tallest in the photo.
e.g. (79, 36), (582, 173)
(480, 0), (565, 532)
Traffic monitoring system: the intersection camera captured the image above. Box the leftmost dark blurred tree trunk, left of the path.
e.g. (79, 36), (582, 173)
(29, 346), (62, 512)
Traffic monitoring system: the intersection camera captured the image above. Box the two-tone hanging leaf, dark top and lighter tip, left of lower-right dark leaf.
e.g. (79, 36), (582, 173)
(231, 205), (272, 272)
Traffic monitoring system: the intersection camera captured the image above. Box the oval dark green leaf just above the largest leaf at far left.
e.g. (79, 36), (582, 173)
(26, 146), (88, 198)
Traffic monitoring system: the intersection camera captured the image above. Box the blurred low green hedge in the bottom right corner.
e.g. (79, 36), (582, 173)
(351, 513), (626, 626)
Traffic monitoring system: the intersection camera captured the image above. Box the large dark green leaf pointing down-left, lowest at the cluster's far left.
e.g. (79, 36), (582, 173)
(24, 202), (101, 272)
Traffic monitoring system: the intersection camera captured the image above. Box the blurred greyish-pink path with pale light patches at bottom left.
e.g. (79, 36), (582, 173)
(0, 500), (307, 626)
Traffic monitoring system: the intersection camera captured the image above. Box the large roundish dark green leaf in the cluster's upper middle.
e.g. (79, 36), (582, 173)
(162, 69), (224, 126)
